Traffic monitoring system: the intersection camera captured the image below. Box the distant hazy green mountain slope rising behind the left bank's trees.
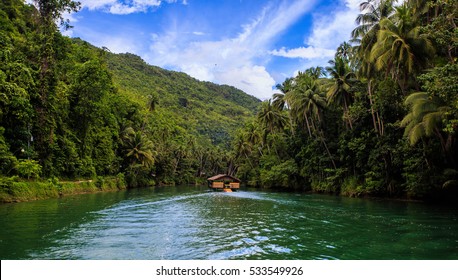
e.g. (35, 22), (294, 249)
(107, 53), (260, 145)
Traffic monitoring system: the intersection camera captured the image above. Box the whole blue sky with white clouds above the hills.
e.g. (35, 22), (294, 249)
(61, 0), (361, 100)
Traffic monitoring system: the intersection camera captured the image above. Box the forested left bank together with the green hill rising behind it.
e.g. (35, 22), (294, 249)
(0, 0), (260, 189)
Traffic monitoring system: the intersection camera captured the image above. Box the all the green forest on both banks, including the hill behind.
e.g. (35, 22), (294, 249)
(0, 0), (458, 201)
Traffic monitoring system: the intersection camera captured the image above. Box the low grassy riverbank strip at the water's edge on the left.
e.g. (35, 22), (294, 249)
(0, 174), (127, 203)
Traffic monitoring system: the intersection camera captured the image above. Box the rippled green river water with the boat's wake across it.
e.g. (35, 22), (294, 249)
(0, 187), (458, 260)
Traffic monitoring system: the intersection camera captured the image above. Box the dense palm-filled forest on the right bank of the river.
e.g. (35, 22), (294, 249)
(233, 0), (458, 199)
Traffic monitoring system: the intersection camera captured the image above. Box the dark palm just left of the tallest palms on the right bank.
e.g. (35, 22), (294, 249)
(326, 56), (356, 129)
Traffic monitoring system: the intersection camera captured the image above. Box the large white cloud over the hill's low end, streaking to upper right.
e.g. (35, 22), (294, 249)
(143, 0), (315, 99)
